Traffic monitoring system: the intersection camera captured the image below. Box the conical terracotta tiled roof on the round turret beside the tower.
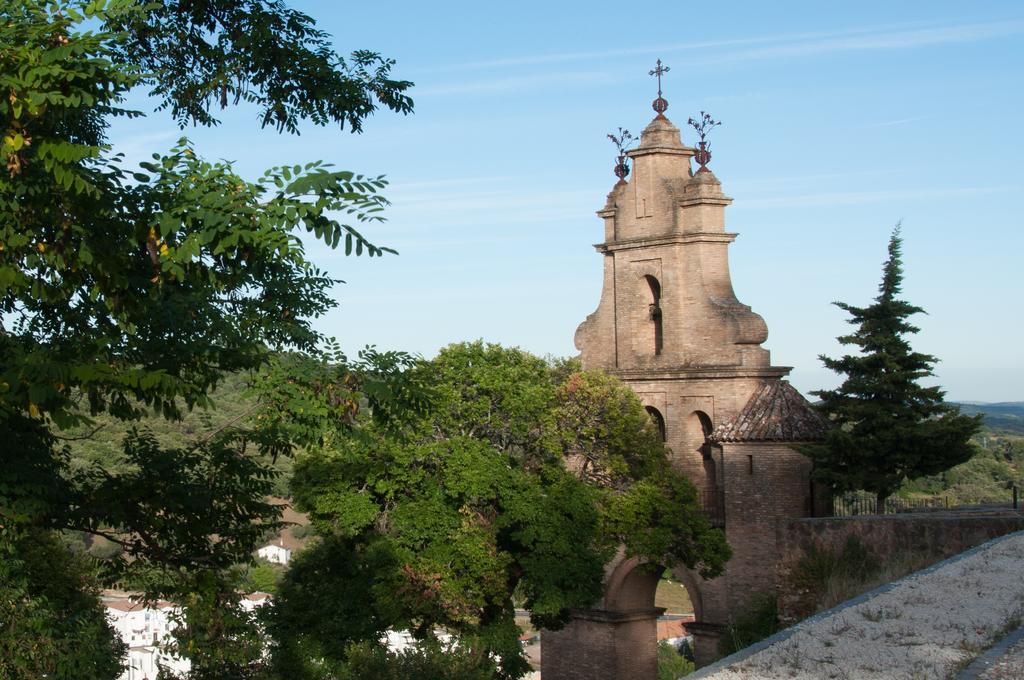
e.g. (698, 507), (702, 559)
(709, 380), (828, 442)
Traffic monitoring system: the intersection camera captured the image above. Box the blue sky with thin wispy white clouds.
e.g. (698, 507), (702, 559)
(112, 1), (1024, 401)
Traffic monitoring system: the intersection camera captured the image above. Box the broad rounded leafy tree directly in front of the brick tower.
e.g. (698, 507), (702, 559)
(266, 342), (729, 678)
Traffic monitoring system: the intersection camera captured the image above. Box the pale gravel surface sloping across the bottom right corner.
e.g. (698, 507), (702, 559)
(695, 532), (1024, 680)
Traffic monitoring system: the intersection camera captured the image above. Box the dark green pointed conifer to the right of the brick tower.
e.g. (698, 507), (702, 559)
(812, 224), (981, 512)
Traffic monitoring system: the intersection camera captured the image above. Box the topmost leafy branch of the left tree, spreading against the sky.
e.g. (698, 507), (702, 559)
(108, 0), (413, 132)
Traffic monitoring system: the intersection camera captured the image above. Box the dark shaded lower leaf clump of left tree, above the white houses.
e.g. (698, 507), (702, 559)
(67, 433), (281, 595)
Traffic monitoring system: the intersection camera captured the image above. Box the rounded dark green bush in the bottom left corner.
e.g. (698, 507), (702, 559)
(0, 525), (127, 680)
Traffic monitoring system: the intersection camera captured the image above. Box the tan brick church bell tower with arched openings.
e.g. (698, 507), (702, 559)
(542, 93), (828, 680)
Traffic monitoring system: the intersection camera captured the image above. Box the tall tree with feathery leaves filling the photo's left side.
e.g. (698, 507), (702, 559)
(0, 0), (412, 678)
